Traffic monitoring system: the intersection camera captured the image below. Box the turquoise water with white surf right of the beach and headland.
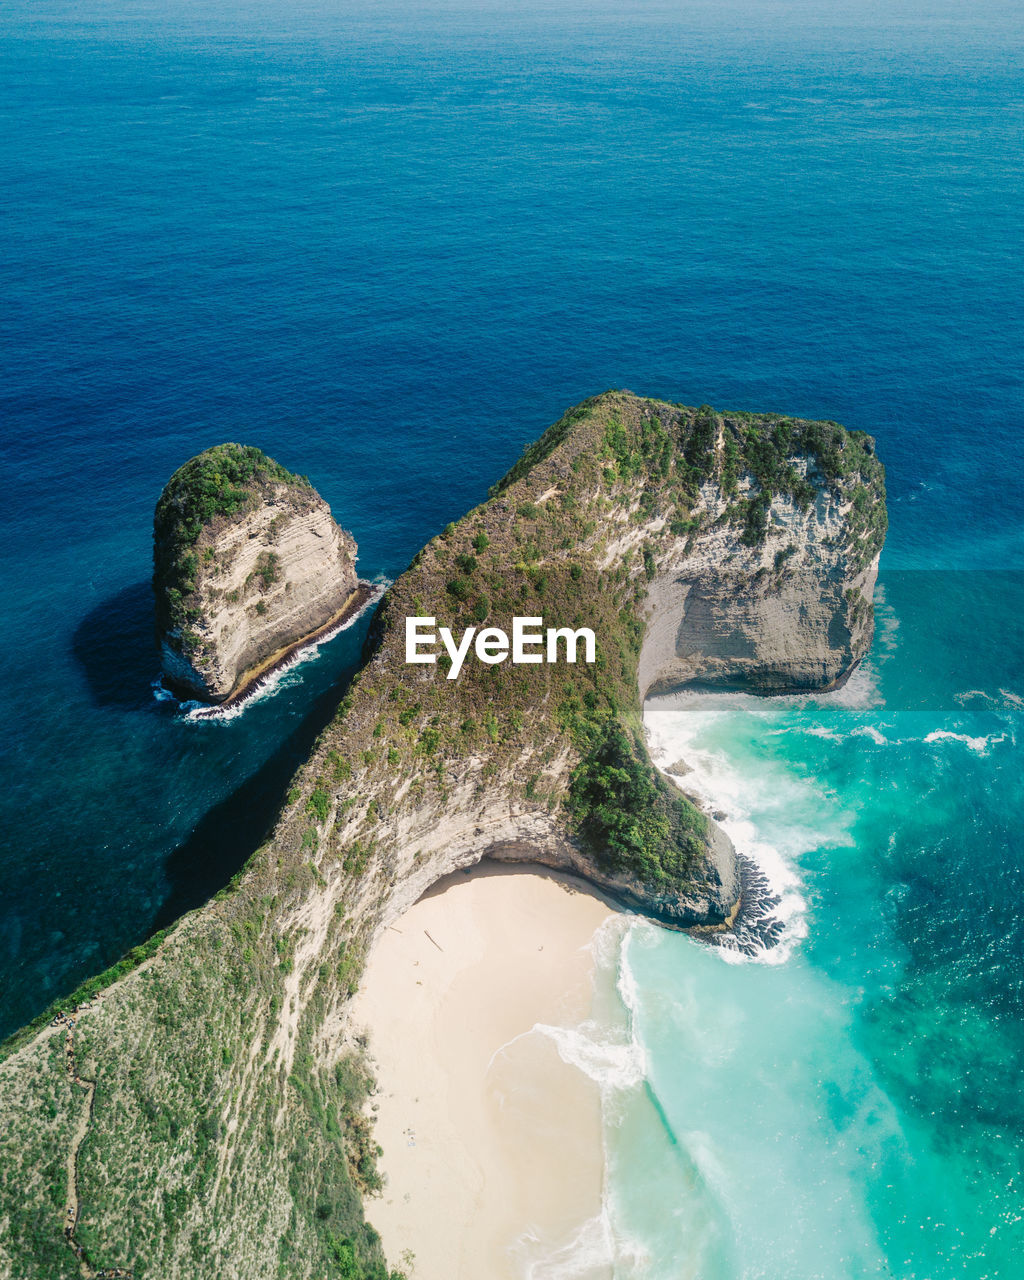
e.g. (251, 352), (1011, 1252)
(583, 573), (1024, 1280)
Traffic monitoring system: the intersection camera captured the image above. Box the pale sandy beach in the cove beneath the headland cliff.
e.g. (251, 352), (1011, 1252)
(353, 864), (613, 1280)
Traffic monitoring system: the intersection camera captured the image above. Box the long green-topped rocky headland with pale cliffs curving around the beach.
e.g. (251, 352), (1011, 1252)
(0, 392), (886, 1280)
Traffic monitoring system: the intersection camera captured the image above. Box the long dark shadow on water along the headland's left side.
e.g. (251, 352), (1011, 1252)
(150, 663), (358, 932)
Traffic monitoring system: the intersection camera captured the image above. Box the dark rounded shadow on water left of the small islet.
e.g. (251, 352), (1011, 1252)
(72, 582), (159, 710)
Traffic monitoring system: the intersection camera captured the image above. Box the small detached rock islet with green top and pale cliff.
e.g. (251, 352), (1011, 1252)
(154, 444), (357, 703)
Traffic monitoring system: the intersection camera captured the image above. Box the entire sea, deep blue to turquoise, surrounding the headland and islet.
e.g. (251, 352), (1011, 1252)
(0, 0), (1024, 1280)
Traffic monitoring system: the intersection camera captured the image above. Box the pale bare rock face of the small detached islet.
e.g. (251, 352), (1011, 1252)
(161, 485), (358, 703)
